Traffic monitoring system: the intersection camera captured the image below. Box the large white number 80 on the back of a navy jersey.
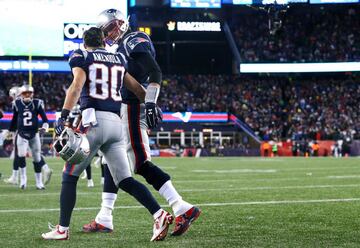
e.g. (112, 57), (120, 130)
(89, 63), (125, 101)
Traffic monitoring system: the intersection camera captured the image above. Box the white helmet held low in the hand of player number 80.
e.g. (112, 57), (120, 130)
(53, 128), (90, 164)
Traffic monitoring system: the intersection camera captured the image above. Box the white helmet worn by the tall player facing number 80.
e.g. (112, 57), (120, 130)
(96, 9), (129, 46)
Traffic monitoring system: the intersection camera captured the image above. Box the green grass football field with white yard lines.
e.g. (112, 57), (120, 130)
(0, 158), (360, 248)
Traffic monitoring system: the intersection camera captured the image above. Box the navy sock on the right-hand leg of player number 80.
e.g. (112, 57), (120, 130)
(119, 177), (160, 215)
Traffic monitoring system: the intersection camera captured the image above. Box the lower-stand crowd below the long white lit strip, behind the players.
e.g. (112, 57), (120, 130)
(0, 73), (360, 140)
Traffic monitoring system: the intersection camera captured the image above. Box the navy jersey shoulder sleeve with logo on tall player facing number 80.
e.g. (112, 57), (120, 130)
(126, 32), (152, 55)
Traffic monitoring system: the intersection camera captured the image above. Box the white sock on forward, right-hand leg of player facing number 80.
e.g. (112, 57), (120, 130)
(159, 180), (193, 216)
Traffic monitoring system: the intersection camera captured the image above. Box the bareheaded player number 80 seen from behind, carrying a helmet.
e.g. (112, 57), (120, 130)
(42, 27), (173, 241)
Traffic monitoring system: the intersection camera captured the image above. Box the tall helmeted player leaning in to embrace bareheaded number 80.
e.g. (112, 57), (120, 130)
(83, 9), (201, 236)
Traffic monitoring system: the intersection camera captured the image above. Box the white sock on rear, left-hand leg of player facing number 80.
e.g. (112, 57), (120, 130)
(95, 192), (117, 229)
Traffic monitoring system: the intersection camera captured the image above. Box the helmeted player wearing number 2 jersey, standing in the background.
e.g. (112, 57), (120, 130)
(9, 85), (51, 189)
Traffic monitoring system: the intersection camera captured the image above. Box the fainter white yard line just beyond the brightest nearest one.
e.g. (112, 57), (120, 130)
(0, 184), (360, 198)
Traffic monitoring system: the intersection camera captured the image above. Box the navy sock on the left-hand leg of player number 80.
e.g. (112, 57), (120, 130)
(59, 174), (79, 227)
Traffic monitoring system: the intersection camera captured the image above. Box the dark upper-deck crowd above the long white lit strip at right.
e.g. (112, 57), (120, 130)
(229, 6), (360, 62)
